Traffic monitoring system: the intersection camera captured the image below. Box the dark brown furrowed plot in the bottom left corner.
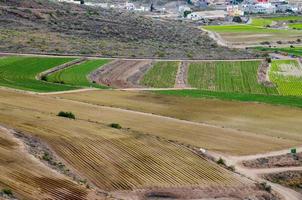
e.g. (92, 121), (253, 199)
(0, 159), (87, 200)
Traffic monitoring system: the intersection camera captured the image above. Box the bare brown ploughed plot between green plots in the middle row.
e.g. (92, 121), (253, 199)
(89, 60), (152, 88)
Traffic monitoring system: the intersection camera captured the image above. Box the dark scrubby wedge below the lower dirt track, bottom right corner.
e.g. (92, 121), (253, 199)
(264, 171), (302, 194)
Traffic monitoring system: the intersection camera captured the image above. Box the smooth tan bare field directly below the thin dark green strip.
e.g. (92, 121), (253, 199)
(54, 91), (302, 143)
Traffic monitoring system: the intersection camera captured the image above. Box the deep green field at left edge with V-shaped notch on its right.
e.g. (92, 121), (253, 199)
(0, 56), (77, 92)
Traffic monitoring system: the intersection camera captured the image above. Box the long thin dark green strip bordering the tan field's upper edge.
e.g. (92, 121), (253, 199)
(154, 90), (302, 108)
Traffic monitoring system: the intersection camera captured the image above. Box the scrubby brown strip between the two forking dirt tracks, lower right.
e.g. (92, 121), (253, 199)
(243, 153), (302, 168)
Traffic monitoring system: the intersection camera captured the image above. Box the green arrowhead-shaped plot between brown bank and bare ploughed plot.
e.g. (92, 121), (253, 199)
(47, 59), (110, 88)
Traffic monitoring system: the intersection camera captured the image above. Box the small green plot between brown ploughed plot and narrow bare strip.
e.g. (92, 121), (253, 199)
(141, 61), (179, 88)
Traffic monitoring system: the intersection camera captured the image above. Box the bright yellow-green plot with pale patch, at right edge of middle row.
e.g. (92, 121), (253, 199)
(269, 60), (302, 96)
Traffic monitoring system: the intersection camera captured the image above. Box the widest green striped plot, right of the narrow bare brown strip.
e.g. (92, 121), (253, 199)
(188, 61), (277, 94)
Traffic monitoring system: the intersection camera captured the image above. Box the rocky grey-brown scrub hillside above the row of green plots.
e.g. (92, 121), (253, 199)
(0, 0), (252, 59)
